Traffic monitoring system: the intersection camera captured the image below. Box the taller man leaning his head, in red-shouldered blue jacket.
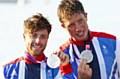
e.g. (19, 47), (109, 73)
(57, 0), (120, 79)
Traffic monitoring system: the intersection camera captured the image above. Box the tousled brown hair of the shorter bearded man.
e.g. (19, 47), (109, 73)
(24, 13), (51, 33)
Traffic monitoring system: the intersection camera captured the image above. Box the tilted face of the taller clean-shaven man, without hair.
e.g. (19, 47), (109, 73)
(62, 13), (88, 40)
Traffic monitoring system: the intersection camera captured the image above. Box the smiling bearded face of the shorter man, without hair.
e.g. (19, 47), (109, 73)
(24, 29), (49, 56)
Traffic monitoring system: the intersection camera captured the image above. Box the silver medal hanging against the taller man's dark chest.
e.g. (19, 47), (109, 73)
(81, 50), (93, 63)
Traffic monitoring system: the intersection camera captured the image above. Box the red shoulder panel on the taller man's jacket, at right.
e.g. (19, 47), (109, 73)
(91, 31), (116, 40)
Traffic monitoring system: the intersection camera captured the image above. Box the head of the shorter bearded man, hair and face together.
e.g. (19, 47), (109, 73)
(23, 13), (51, 56)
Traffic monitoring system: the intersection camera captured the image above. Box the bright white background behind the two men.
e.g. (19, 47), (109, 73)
(0, 0), (120, 79)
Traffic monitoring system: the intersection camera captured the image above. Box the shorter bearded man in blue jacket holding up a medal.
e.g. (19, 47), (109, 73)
(4, 13), (72, 79)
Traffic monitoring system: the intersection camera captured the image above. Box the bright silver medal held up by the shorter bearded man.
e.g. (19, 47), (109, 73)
(47, 54), (60, 68)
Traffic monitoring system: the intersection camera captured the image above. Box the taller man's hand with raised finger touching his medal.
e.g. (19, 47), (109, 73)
(78, 59), (92, 79)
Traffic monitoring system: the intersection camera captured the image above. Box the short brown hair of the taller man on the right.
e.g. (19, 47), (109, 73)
(57, 0), (85, 22)
